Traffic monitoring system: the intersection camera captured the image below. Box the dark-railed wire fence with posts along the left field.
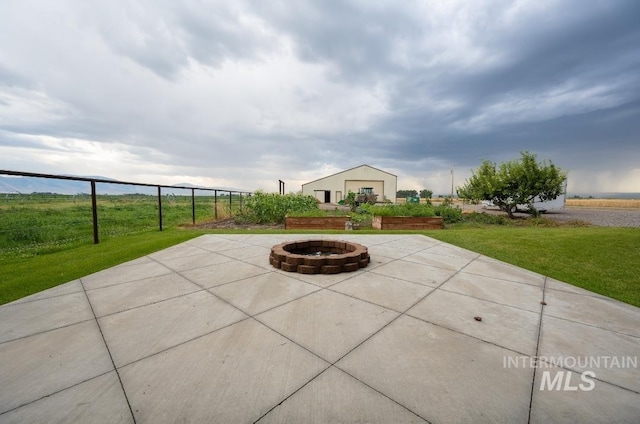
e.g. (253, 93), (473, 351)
(0, 170), (251, 253)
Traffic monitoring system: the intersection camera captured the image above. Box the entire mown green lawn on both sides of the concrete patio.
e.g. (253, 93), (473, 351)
(0, 226), (640, 306)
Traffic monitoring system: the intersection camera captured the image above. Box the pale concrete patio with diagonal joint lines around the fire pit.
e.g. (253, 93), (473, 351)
(0, 232), (640, 423)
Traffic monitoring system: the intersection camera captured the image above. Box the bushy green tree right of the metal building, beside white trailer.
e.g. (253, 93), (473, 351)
(458, 152), (567, 218)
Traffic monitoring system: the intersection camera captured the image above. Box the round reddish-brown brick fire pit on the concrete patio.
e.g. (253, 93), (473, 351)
(269, 240), (369, 274)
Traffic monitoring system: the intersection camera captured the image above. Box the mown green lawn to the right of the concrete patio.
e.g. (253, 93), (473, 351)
(427, 227), (640, 306)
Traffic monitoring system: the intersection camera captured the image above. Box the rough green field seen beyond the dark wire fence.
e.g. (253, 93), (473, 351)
(0, 194), (239, 258)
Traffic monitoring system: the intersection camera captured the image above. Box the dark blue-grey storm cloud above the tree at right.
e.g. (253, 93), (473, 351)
(344, 2), (640, 173)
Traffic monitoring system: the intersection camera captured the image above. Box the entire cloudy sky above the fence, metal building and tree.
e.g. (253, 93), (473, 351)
(0, 0), (640, 193)
